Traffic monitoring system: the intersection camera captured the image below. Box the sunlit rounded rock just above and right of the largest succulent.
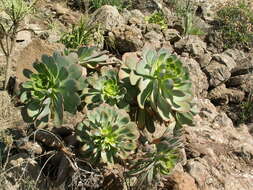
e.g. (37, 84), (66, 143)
(175, 35), (206, 57)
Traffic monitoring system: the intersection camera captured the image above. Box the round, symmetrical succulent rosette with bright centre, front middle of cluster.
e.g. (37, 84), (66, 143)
(76, 104), (139, 164)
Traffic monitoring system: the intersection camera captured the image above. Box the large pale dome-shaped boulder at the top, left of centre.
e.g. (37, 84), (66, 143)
(89, 5), (125, 31)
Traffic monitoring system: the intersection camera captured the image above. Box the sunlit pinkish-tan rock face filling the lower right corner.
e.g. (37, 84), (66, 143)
(184, 99), (253, 190)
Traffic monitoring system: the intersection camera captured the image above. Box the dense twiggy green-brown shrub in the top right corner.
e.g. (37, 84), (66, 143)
(216, 1), (253, 49)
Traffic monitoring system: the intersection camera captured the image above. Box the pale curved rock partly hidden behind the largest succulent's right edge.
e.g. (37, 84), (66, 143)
(180, 57), (208, 97)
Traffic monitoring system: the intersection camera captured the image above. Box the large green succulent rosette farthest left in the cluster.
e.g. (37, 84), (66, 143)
(20, 53), (82, 124)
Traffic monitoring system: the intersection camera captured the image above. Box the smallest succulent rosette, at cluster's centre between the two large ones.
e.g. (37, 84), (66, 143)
(82, 67), (127, 109)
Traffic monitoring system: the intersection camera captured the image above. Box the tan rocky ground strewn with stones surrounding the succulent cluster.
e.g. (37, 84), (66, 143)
(0, 0), (253, 190)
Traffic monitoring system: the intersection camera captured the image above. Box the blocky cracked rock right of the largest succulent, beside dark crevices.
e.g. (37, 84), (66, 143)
(204, 60), (231, 87)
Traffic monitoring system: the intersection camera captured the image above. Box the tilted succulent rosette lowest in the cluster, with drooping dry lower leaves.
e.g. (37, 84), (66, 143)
(126, 136), (180, 190)
